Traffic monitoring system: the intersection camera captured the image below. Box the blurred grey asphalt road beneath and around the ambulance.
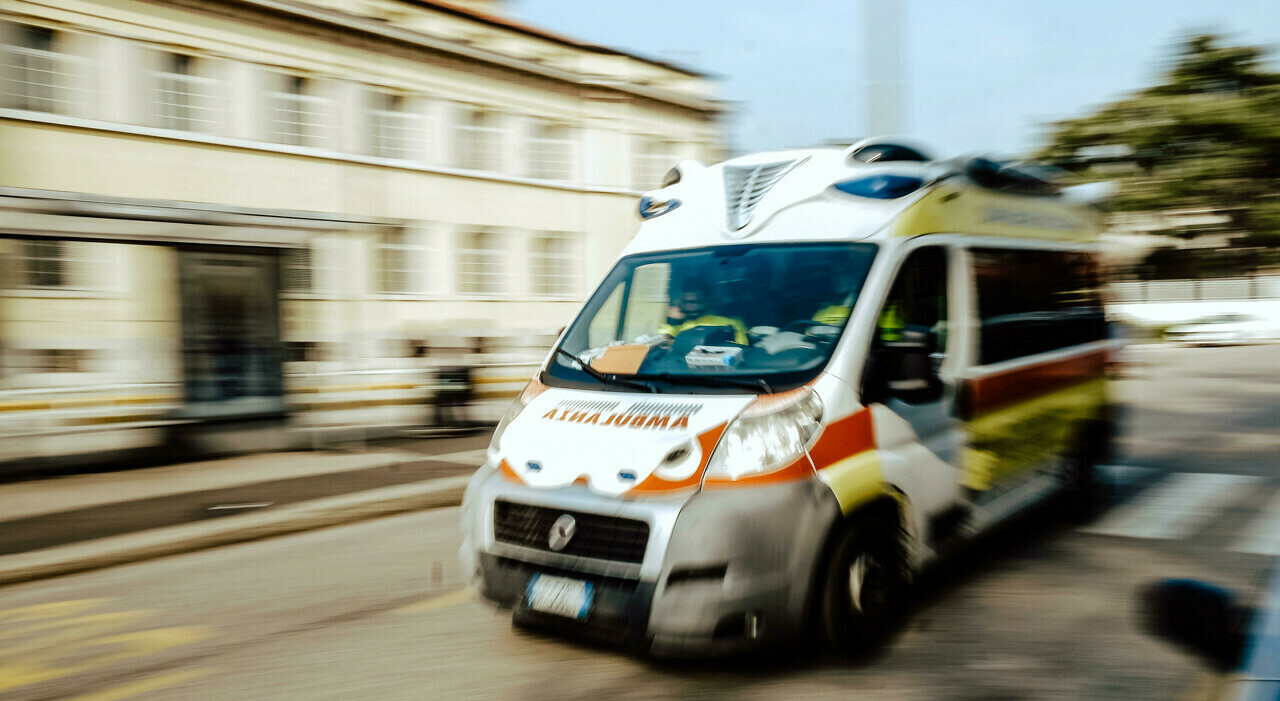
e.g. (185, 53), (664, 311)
(0, 347), (1280, 701)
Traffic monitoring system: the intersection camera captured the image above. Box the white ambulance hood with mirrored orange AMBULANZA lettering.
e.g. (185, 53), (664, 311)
(488, 388), (755, 496)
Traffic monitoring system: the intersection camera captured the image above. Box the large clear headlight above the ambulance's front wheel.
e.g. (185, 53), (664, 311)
(707, 388), (822, 482)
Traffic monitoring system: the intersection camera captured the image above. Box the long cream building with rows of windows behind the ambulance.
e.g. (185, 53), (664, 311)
(0, 0), (722, 462)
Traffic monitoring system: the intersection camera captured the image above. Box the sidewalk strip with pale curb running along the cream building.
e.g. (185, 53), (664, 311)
(0, 434), (489, 585)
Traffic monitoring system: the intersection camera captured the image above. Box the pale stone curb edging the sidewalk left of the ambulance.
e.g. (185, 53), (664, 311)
(0, 476), (471, 586)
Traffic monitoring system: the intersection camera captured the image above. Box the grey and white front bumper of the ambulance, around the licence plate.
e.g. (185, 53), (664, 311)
(461, 468), (840, 656)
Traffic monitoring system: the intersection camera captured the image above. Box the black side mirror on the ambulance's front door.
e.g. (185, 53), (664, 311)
(863, 326), (942, 404)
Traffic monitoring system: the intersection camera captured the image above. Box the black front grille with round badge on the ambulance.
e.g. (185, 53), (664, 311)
(493, 499), (649, 563)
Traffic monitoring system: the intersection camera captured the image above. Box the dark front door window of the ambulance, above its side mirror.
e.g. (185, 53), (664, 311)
(876, 246), (947, 353)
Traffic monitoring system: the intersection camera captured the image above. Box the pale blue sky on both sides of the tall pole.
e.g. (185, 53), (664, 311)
(507, 0), (1280, 156)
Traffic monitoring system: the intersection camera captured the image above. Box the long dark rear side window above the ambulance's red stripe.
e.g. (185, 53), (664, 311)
(973, 248), (1107, 363)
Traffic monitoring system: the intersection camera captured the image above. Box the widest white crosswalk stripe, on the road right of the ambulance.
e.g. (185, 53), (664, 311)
(1082, 472), (1262, 540)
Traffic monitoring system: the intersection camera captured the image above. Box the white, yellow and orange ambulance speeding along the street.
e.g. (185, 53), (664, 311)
(461, 139), (1115, 656)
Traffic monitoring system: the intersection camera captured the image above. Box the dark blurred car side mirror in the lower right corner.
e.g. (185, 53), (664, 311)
(1142, 579), (1249, 672)
